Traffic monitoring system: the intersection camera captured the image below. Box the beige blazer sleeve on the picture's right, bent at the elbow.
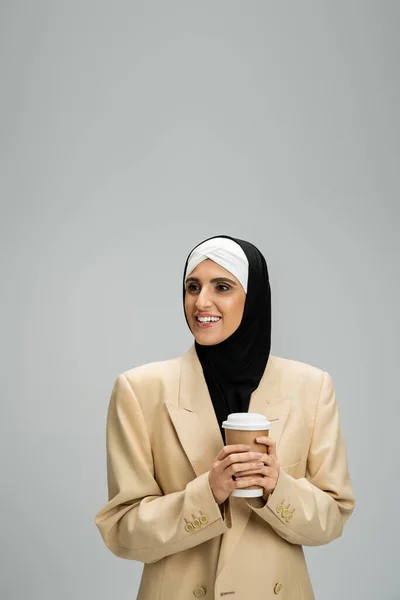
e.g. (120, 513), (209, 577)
(248, 373), (355, 546)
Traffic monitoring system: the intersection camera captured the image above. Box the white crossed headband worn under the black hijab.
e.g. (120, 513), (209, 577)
(185, 238), (249, 293)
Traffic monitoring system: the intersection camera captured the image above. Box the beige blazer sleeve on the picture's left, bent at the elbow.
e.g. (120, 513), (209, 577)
(95, 374), (231, 563)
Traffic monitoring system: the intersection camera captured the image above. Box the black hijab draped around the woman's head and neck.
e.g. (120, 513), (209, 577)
(183, 235), (271, 440)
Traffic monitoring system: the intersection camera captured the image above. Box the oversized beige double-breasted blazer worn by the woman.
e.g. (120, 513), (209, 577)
(95, 346), (354, 600)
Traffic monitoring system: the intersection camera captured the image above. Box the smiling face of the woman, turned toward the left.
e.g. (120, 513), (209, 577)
(185, 259), (246, 346)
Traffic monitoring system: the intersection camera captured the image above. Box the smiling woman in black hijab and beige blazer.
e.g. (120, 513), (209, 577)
(96, 236), (354, 600)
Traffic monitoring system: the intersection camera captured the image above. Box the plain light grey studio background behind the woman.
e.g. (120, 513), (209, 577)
(0, 0), (400, 600)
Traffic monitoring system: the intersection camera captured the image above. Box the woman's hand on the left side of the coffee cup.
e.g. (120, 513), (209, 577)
(208, 444), (265, 504)
